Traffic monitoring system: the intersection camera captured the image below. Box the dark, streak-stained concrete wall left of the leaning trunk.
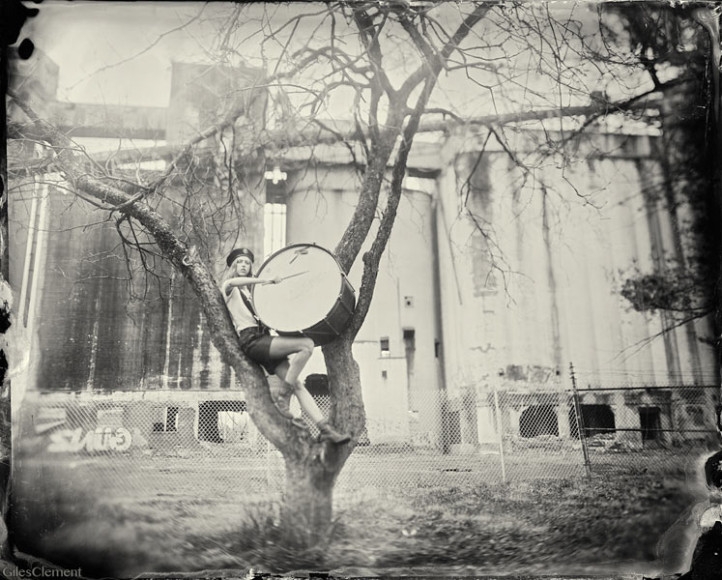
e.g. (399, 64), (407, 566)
(10, 178), (262, 391)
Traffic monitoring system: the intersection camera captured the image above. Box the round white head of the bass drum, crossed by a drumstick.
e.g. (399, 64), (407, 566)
(253, 244), (343, 332)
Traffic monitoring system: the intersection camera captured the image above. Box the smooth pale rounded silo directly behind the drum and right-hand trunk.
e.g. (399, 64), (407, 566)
(287, 167), (443, 444)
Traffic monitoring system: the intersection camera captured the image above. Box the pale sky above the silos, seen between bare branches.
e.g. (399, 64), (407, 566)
(19, 0), (656, 145)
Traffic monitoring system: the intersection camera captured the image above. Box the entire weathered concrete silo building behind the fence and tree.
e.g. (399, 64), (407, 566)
(10, 53), (718, 452)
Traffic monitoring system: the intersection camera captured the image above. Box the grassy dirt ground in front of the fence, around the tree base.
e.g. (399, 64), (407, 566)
(11, 450), (693, 578)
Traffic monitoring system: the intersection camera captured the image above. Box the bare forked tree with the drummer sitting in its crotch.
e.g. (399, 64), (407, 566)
(11, 1), (716, 542)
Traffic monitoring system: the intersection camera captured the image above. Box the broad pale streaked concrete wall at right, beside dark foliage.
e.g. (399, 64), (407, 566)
(437, 133), (716, 442)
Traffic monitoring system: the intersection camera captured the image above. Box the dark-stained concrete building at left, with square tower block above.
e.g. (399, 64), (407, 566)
(9, 58), (265, 392)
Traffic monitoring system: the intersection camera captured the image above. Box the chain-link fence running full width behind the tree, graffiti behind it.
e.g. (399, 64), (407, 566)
(15, 378), (719, 497)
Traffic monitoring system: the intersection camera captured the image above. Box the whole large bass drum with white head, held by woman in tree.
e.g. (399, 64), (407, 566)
(253, 244), (356, 346)
